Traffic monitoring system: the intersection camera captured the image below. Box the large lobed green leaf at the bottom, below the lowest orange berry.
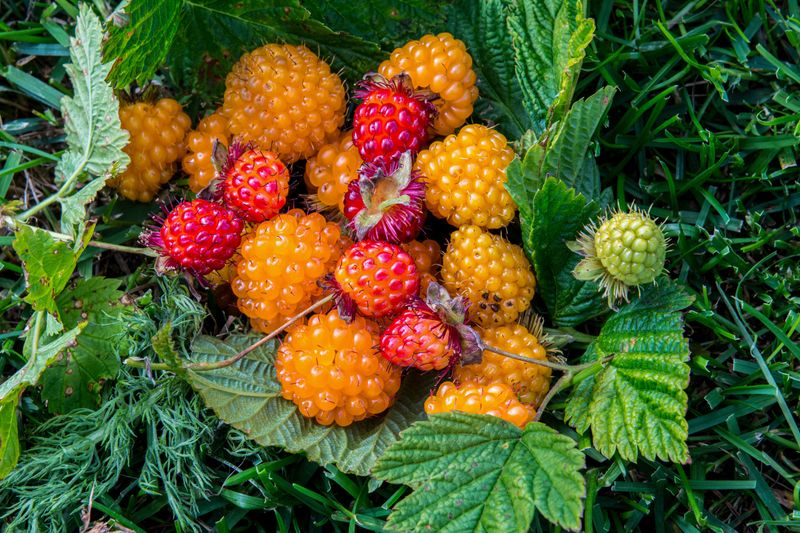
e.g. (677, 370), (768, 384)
(373, 412), (585, 532)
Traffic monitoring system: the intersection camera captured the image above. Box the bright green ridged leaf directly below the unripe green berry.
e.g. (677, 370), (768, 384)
(566, 278), (692, 462)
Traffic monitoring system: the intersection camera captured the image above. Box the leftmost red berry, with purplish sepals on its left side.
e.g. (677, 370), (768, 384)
(142, 198), (244, 276)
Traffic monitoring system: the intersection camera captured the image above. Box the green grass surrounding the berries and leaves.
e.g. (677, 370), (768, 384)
(0, 0), (800, 532)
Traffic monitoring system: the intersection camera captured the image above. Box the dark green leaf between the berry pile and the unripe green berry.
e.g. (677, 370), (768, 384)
(522, 178), (608, 326)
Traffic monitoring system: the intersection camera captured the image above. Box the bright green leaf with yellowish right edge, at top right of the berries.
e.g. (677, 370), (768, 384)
(507, 0), (594, 134)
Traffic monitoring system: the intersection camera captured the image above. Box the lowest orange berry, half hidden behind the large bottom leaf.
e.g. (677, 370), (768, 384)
(425, 381), (536, 428)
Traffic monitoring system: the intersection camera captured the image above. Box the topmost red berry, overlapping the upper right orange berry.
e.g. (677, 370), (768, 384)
(353, 73), (436, 164)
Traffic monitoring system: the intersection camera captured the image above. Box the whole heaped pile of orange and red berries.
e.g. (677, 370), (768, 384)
(130, 33), (550, 426)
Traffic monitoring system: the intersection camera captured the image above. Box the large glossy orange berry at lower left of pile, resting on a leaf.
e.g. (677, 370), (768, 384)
(275, 309), (401, 426)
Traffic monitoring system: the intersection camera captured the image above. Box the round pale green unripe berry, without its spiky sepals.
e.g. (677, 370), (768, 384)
(594, 211), (667, 286)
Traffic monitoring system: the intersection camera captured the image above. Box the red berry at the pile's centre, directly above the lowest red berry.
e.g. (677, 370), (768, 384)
(334, 241), (419, 318)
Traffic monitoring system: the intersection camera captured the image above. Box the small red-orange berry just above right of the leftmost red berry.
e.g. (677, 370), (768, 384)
(222, 144), (289, 222)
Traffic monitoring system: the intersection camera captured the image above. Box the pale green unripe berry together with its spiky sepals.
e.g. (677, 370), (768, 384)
(571, 209), (667, 303)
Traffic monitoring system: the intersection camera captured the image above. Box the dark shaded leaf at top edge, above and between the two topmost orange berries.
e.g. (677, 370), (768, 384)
(304, 0), (449, 50)
